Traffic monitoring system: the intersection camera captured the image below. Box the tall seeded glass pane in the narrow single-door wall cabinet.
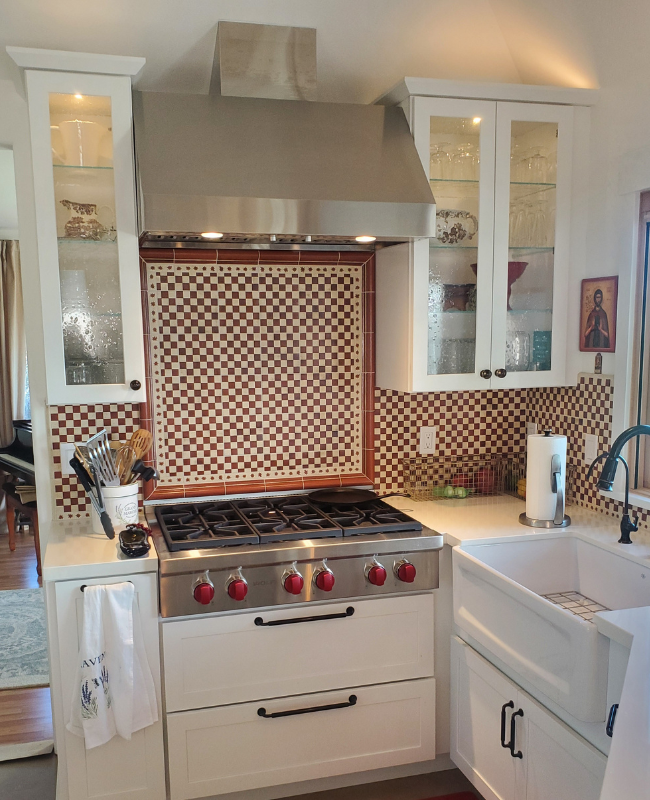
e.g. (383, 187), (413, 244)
(50, 94), (124, 385)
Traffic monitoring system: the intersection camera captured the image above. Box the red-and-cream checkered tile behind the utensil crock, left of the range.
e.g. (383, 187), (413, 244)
(50, 403), (140, 519)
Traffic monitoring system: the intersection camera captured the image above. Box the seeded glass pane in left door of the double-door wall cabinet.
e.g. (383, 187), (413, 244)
(427, 117), (481, 375)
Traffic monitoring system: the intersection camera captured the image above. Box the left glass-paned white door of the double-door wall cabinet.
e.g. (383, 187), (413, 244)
(414, 98), (495, 390)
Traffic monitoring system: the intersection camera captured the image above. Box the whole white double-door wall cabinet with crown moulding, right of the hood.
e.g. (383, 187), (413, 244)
(376, 79), (593, 392)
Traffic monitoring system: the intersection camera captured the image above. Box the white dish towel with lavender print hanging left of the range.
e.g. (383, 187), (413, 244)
(67, 582), (158, 750)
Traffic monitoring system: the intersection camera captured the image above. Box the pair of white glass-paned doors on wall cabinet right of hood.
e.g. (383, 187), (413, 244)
(412, 97), (573, 390)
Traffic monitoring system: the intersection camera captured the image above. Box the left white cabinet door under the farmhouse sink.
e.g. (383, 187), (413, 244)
(450, 638), (516, 800)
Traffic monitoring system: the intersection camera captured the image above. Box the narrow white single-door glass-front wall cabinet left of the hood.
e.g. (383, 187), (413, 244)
(8, 48), (146, 405)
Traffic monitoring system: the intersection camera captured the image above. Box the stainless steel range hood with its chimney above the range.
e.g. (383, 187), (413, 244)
(134, 22), (435, 246)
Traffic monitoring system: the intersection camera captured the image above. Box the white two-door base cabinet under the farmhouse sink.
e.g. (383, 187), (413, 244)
(450, 637), (607, 800)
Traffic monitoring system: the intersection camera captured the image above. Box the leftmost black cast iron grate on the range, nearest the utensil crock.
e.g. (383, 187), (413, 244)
(156, 502), (259, 552)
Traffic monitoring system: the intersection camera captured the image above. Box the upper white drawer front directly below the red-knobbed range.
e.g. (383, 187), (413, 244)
(162, 592), (433, 711)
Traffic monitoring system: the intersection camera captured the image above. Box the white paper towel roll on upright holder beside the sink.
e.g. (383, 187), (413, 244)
(526, 433), (566, 520)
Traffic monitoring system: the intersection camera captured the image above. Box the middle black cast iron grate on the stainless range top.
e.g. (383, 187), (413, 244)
(233, 496), (343, 544)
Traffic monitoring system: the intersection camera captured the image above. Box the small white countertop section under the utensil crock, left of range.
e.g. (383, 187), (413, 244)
(41, 518), (158, 581)
